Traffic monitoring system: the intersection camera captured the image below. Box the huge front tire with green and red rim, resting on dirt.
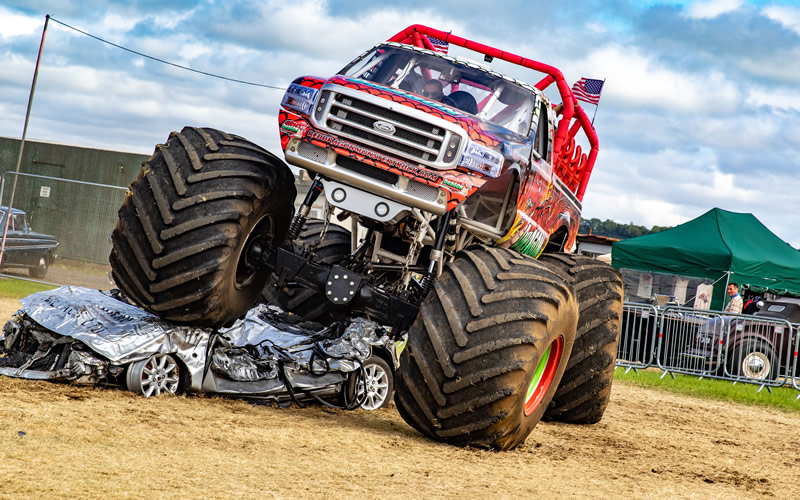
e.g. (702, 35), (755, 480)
(395, 246), (578, 450)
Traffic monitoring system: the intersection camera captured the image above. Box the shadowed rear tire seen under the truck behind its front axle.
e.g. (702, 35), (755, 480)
(261, 219), (351, 321)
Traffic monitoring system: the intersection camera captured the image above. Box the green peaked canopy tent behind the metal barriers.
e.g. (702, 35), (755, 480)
(611, 208), (800, 309)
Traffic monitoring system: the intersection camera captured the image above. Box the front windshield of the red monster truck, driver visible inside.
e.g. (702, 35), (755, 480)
(340, 45), (535, 135)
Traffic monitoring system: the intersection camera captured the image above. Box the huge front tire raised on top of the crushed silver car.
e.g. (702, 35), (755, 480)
(109, 127), (296, 327)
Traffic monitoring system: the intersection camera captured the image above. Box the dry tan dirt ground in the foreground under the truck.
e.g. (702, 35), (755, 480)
(0, 294), (800, 498)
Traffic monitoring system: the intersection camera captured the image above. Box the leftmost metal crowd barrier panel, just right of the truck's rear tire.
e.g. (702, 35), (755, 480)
(617, 302), (658, 369)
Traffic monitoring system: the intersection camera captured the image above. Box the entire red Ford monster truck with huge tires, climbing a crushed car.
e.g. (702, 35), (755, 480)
(110, 25), (622, 449)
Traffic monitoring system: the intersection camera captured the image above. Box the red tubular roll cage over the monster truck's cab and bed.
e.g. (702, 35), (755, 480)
(388, 24), (598, 200)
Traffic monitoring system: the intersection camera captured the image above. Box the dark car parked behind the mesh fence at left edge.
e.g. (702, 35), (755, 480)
(0, 207), (58, 279)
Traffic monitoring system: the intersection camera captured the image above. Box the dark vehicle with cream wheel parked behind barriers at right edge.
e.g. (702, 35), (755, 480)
(683, 297), (800, 380)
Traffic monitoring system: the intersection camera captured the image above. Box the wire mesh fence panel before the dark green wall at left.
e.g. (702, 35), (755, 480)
(0, 172), (127, 288)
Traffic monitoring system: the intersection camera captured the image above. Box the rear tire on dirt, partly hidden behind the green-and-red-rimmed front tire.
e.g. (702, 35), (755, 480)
(539, 253), (623, 424)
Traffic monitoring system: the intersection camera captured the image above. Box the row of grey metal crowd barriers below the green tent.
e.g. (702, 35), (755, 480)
(617, 303), (800, 399)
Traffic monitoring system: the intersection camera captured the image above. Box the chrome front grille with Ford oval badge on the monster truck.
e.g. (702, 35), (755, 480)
(320, 92), (458, 164)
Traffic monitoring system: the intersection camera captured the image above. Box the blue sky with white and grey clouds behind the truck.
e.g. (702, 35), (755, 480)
(0, 0), (800, 247)
